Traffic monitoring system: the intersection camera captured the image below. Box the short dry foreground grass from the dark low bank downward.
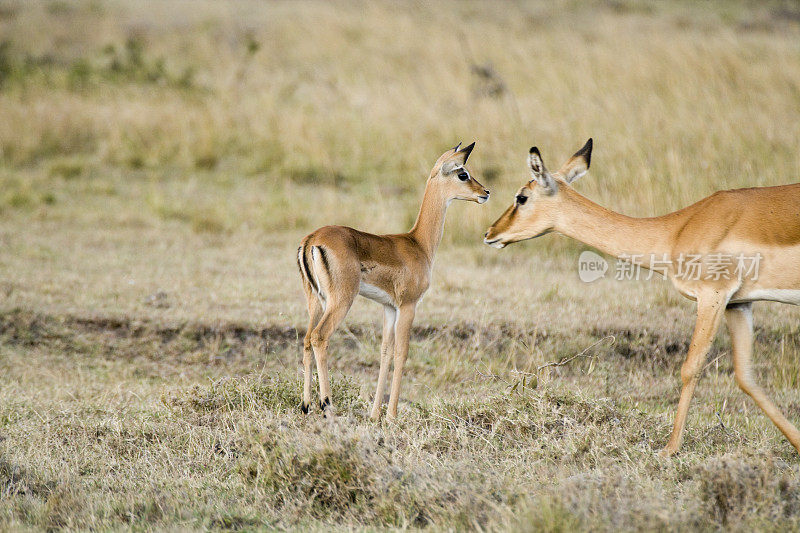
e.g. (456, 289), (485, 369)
(0, 311), (798, 530)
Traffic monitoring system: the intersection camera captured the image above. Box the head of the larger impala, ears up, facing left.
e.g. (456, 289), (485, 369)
(483, 139), (592, 248)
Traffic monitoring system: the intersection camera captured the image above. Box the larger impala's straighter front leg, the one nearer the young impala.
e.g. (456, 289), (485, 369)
(661, 290), (729, 456)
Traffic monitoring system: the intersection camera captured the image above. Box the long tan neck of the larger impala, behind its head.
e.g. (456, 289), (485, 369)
(555, 187), (676, 262)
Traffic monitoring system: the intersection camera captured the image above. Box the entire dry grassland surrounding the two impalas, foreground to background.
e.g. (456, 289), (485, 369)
(0, 0), (800, 531)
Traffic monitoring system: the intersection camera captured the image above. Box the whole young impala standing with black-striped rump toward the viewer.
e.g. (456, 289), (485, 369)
(297, 143), (489, 419)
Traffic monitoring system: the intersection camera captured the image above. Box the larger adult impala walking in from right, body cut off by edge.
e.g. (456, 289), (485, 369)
(484, 139), (800, 455)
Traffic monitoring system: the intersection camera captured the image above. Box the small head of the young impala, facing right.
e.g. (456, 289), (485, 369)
(428, 143), (489, 204)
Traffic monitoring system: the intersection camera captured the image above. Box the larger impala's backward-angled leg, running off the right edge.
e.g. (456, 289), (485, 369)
(725, 303), (800, 452)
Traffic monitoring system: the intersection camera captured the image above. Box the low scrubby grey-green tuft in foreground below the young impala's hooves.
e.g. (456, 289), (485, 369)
(239, 427), (450, 528)
